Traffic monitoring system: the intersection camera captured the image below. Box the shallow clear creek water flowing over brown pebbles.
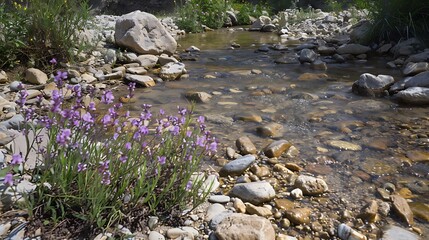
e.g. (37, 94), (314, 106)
(125, 29), (429, 236)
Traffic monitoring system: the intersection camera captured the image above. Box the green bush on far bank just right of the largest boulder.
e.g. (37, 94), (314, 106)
(176, 0), (228, 32)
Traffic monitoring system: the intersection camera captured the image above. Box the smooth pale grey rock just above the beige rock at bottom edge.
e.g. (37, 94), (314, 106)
(230, 182), (276, 205)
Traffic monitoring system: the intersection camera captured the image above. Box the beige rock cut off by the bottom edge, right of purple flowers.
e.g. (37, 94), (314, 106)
(215, 213), (276, 240)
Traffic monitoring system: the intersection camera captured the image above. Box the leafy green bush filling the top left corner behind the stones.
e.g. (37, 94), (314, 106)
(0, 0), (90, 67)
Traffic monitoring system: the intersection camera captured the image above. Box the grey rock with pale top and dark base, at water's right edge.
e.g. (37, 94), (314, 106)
(352, 73), (395, 97)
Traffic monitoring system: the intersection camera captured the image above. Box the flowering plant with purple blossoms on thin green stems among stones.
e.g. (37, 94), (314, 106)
(5, 72), (217, 234)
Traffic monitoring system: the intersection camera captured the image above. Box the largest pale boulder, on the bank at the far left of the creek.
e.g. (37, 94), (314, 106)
(115, 11), (177, 54)
